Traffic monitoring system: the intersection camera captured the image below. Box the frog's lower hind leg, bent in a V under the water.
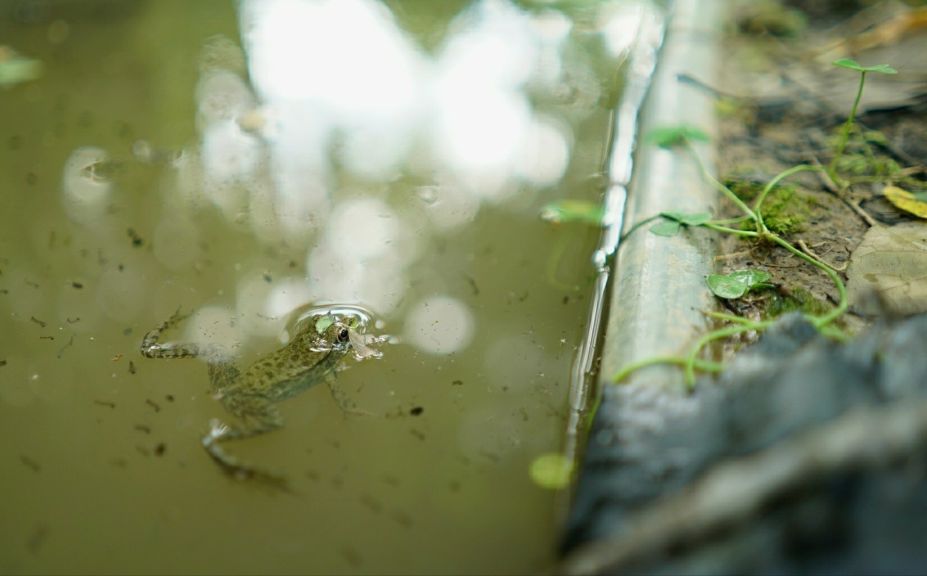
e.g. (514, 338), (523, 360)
(202, 406), (286, 489)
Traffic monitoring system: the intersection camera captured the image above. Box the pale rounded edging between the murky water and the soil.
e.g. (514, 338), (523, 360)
(599, 0), (723, 391)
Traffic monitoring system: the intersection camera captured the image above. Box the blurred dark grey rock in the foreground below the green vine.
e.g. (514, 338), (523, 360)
(563, 316), (927, 574)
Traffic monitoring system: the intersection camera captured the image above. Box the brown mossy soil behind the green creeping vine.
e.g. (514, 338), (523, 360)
(708, 2), (927, 340)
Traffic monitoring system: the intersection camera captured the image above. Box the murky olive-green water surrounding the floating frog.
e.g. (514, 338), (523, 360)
(0, 0), (632, 573)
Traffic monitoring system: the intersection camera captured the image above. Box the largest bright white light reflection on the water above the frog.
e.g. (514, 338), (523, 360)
(176, 0), (572, 326)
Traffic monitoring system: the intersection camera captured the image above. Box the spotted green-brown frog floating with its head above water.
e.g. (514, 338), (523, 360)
(140, 307), (385, 486)
